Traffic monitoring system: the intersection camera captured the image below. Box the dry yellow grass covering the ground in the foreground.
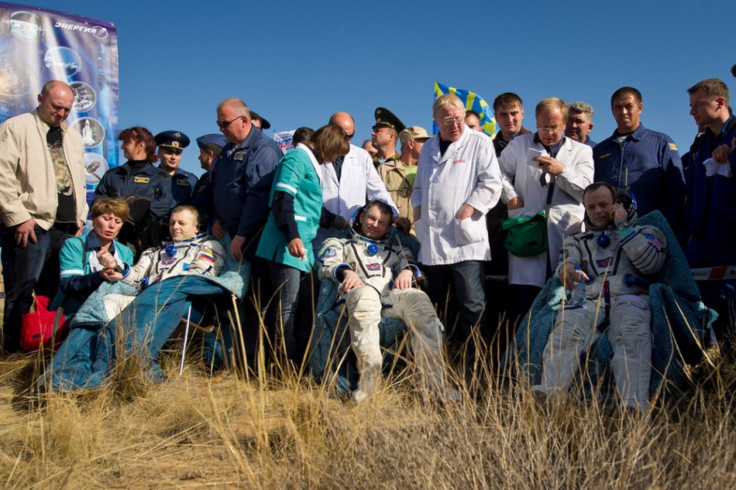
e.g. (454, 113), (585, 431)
(0, 336), (736, 489)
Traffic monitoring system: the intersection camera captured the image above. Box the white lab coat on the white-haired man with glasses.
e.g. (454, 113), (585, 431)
(411, 126), (501, 265)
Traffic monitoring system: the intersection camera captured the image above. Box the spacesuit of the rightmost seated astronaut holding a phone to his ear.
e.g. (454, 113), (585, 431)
(533, 212), (666, 412)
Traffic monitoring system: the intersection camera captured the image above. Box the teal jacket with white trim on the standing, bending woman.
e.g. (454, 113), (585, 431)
(256, 145), (322, 272)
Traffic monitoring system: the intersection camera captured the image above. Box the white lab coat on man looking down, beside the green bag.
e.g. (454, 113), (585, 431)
(499, 133), (593, 287)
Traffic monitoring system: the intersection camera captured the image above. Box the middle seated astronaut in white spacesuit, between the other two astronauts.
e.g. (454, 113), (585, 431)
(319, 201), (459, 402)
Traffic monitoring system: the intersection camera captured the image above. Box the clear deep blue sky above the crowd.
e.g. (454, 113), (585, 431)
(7, 0), (736, 174)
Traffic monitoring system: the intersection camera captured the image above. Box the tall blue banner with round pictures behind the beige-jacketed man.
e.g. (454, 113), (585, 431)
(0, 2), (119, 195)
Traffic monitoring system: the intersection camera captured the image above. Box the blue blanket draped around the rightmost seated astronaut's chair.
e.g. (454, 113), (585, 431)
(504, 211), (712, 398)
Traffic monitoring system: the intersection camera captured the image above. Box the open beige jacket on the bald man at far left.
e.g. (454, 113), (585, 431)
(0, 110), (88, 230)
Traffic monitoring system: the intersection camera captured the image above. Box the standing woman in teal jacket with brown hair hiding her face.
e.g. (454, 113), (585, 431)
(256, 125), (350, 362)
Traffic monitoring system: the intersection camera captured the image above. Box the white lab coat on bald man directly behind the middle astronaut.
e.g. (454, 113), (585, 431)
(312, 141), (399, 249)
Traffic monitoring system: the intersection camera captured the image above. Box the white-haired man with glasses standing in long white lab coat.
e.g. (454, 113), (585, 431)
(411, 94), (501, 346)
